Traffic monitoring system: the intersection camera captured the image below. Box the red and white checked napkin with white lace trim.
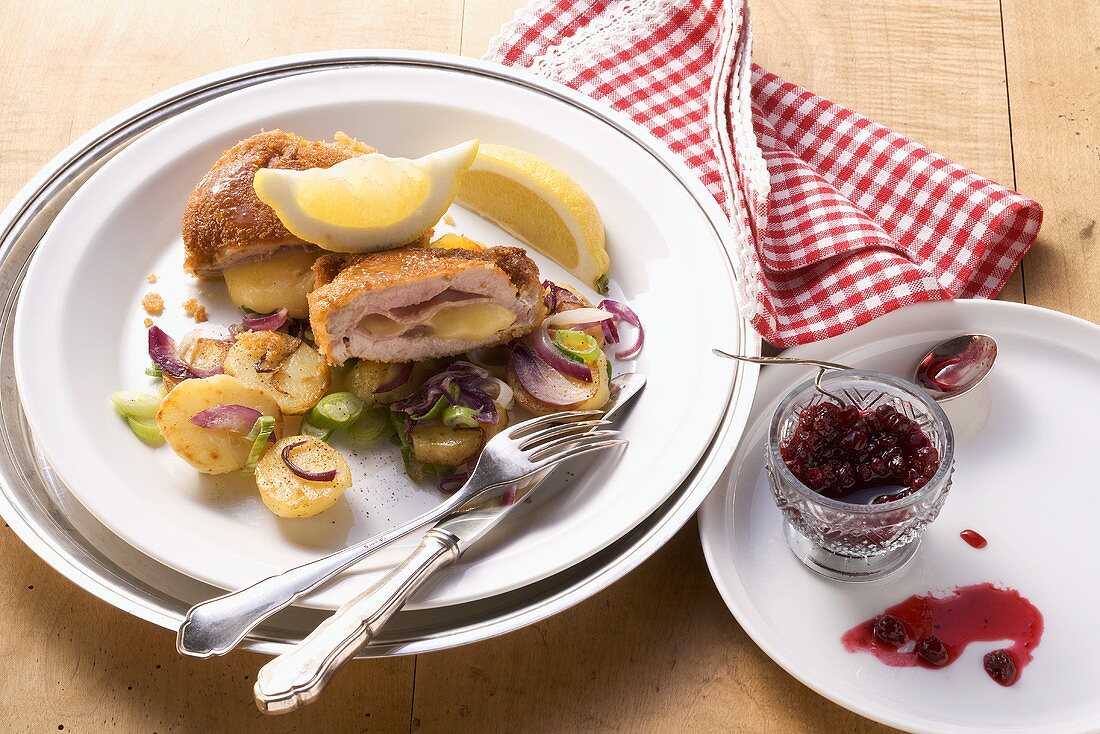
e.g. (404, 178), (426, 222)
(485, 0), (1043, 347)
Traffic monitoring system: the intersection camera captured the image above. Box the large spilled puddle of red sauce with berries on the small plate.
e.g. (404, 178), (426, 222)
(840, 583), (1043, 686)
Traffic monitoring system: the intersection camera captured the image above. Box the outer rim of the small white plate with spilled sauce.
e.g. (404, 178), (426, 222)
(696, 299), (1100, 734)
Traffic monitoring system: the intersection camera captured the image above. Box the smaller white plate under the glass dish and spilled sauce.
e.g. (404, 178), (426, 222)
(700, 300), (1100, 732)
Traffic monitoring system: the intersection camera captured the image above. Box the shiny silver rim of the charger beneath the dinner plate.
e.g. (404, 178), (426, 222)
(0, 50), (760, 651)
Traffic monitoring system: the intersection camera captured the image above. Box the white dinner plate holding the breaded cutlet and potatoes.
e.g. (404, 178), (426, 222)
(15, 57), (739, 609)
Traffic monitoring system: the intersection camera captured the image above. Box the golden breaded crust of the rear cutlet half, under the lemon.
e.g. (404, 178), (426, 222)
(183, 130), (375, 277)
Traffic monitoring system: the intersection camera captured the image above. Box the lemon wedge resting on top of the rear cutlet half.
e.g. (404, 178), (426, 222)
(252, 140), (477, 252)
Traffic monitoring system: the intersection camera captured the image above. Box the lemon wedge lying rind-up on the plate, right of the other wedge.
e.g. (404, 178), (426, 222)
(458, 143), (611, 293)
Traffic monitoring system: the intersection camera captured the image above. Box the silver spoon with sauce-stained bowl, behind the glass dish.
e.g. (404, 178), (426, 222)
(712, 333), (997, 403)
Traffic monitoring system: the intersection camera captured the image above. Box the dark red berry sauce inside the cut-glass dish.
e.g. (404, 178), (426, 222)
(779, 403), (939, 504)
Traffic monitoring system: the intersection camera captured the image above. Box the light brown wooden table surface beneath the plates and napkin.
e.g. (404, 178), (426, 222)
(0, 0), (1100, 734)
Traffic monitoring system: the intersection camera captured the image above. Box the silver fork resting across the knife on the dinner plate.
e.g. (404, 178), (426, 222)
(176, 410), (625, 658)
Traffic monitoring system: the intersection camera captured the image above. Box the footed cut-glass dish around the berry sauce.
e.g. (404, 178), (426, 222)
(766, 370), (955, 581)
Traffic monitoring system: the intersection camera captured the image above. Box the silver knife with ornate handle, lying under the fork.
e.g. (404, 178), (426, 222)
(253, 373), (646, 714)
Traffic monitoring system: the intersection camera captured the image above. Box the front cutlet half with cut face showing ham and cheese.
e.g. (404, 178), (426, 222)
(309, 247), (546, 364)
